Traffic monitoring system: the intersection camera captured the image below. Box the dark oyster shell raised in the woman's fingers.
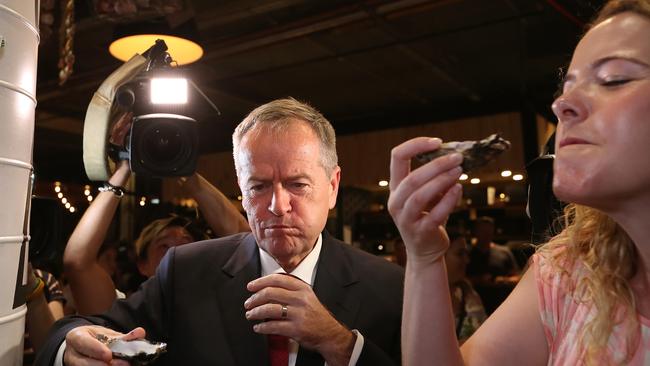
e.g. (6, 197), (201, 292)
(415, 133), (510, 173)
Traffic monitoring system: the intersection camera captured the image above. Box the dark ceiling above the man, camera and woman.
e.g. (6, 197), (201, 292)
(34, 0), (602, 182)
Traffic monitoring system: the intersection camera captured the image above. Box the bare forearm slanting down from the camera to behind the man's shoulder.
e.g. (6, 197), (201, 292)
(180, 173), (250, 236)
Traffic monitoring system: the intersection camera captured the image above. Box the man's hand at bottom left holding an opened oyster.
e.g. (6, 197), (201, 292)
(63, 325), (146, 366)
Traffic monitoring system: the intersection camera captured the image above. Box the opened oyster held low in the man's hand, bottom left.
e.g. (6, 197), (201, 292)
(97, 334), (167, 365)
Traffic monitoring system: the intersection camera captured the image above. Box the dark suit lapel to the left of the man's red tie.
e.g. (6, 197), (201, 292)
(217, 234), (268, 365)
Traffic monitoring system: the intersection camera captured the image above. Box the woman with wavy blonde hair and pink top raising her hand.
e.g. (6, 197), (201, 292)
(388, 0), (650, 365)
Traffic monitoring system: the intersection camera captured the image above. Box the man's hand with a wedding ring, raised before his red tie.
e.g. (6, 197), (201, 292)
(244, 274), (356, 366)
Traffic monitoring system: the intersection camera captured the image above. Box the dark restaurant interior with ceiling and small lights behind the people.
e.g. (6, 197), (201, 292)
(29, 0), (602, 266)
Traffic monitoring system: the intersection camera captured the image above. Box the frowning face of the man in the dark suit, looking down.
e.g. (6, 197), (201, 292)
(236, 120), (340, 271)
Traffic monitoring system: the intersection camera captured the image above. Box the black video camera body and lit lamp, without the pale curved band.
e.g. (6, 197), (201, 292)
(116, 40), (199, 177)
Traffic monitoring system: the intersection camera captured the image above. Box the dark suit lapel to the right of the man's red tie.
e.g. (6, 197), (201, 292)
(296, 231), (361, 366)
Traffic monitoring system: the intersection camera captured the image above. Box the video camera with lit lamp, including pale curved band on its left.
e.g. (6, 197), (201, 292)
(84, 40), (218, 180)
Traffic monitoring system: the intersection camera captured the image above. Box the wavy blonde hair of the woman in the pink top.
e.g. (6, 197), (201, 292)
(539, 0), (650, 364)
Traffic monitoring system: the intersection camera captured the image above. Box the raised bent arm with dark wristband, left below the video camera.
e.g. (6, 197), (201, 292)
(63, 161), (130, 315)
